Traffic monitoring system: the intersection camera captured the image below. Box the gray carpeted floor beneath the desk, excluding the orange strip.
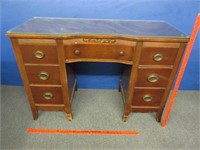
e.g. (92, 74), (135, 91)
(1, 86), (200, 150)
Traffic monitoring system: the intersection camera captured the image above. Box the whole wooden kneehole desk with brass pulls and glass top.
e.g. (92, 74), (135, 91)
(7, 17), (189, 121)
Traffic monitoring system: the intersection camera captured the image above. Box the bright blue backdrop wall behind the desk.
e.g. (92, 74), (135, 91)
(1, 0), (200, 90)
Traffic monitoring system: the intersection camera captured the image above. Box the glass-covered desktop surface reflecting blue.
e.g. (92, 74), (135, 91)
(7, 17), (187, 38)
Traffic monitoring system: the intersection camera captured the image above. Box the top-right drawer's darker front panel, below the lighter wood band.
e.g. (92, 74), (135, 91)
(139, 47), (178, 65)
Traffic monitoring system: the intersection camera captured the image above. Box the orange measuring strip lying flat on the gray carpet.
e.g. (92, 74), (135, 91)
(26, 128), (140, 135)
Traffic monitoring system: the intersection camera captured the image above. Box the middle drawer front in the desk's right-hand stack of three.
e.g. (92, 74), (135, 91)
(136, 68), (172, 87)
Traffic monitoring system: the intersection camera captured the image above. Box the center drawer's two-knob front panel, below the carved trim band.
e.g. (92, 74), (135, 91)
(65, 44), (134, 61)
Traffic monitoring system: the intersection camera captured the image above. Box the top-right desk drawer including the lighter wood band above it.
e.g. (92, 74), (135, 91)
(139, 42), (179, 65)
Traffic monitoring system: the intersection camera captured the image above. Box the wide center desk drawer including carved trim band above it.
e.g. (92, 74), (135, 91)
(64, 39), (135, 64)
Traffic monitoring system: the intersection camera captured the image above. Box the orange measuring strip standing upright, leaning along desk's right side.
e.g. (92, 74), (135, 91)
(162, 14), (200, 127)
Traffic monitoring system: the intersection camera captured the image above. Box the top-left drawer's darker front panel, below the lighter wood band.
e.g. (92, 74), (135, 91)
(20, 45), (58, 64)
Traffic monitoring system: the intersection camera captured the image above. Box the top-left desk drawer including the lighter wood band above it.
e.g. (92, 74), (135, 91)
(19, 39), (58, 64)
